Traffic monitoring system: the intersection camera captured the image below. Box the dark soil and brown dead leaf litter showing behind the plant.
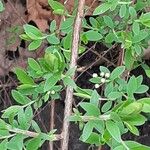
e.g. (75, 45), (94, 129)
(0, 0), (150, 150)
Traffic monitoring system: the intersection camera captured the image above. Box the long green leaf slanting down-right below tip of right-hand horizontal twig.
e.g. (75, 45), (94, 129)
(106, 121), (122, 143)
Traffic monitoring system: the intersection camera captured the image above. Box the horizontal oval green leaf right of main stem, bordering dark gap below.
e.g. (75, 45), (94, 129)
(84, 30), (103, 41)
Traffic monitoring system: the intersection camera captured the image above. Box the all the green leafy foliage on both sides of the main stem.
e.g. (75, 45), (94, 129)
(0, 0), (150, 150)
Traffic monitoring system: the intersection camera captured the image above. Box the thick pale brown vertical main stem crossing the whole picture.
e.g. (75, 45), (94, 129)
(61, 0), (85, 150)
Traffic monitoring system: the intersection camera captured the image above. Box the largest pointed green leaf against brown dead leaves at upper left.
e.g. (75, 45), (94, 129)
(23, 24), (44, 40)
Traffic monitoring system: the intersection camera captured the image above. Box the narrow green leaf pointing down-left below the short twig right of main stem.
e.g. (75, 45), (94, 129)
(81, 121), (93, 142)
